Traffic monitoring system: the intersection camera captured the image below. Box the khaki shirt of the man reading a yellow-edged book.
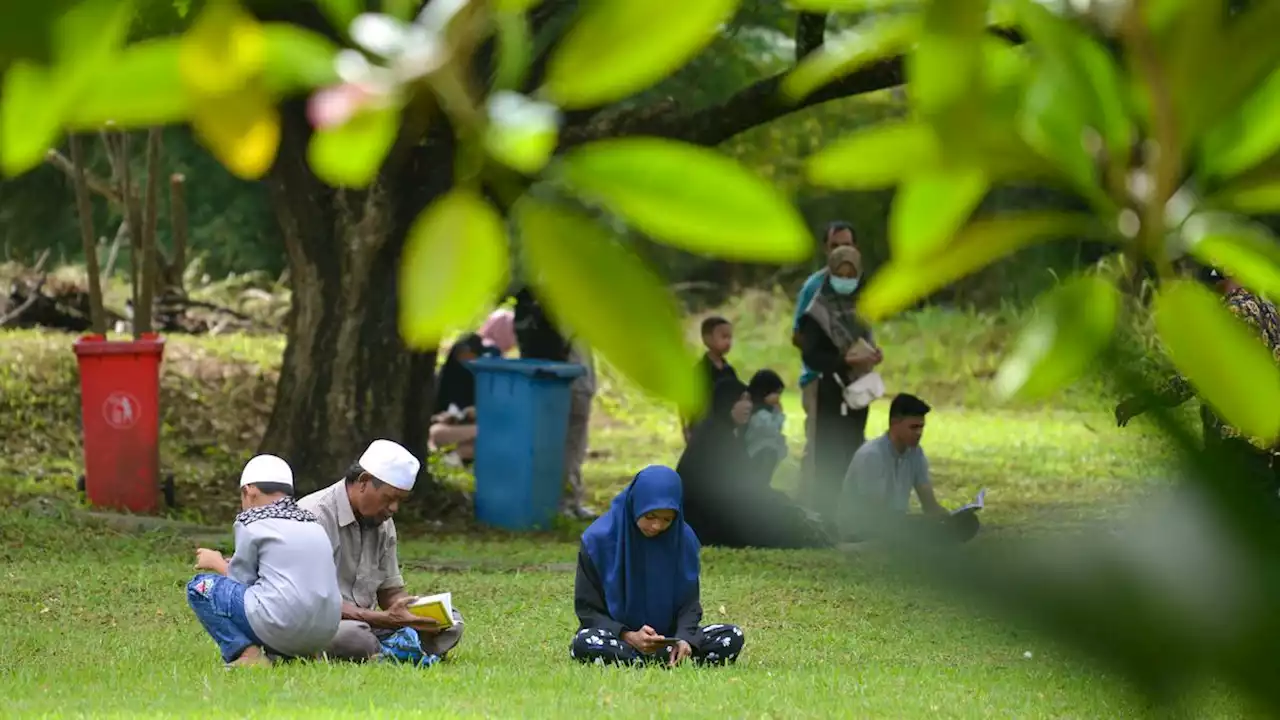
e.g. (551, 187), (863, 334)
(298, 480), (404, 610)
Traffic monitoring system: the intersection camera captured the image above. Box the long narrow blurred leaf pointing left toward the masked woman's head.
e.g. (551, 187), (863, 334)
(858, 211), (1100, 322)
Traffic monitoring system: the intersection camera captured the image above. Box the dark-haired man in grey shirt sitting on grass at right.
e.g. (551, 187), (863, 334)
(840, 393), (978, 542)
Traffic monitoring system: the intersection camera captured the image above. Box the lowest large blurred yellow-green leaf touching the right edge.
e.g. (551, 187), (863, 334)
(1155, 281), (1280, 441)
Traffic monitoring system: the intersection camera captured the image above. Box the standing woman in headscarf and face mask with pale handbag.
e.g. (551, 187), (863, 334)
(799, 246), (884, 521)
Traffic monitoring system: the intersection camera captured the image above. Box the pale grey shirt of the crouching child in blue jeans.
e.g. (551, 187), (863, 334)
(227, 518), (342, 657)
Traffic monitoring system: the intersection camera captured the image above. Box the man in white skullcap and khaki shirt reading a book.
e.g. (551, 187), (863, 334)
(298, 439), (462, 665)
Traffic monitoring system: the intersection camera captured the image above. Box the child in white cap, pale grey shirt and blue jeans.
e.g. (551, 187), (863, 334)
(187, 455), (342, 666)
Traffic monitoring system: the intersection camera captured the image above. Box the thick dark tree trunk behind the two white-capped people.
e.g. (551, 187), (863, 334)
(261, 102), (458, 512)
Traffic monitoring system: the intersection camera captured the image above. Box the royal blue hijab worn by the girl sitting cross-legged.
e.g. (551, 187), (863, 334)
(582, 465), (699, 635)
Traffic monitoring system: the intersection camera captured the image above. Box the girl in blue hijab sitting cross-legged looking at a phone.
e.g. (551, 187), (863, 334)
(570, 465), (744, 666)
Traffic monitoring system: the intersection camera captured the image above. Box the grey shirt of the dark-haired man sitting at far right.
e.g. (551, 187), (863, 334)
(840, 433), (929, 534)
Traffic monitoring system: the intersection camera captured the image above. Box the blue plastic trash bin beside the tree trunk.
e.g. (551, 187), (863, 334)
(467, 357), (586, 530)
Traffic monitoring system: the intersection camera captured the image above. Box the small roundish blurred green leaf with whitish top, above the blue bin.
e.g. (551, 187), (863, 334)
(484, 91), (559, 174)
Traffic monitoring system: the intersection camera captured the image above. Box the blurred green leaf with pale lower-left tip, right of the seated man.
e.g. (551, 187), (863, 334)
(996, 275), (1120, 400)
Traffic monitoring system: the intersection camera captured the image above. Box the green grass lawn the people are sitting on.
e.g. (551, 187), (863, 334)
(0, 289), (1248, 719)
